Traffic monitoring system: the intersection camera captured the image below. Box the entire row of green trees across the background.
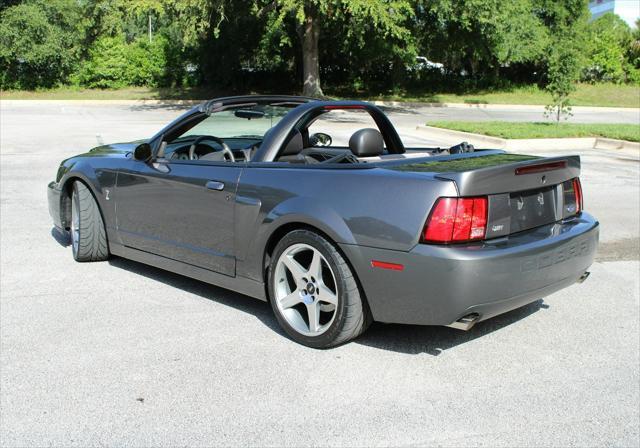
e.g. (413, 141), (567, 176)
(0, 0), (640, 94)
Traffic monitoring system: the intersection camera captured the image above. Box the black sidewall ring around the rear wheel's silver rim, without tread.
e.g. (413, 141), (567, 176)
(268, 230), (348, 348)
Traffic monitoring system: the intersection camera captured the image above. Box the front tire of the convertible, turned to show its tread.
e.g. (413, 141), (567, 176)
(71, 181), (109, 261)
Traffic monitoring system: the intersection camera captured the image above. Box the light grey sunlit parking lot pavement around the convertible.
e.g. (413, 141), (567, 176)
(0, 104), (640, 446)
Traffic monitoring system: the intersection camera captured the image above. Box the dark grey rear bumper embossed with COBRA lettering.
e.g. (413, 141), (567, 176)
(341, 213), (599, 325)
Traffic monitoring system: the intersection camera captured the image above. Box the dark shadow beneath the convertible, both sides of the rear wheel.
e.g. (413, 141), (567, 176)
(109, 257), (548, 356)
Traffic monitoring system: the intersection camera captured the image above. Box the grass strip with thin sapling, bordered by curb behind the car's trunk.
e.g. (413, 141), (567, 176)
(427, 121), (640, 142)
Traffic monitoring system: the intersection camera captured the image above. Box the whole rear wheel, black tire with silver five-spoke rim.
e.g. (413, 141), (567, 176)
(269, 230), (371, 348)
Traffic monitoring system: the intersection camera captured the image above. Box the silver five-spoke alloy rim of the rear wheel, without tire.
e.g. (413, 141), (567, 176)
(274, 243), (338, 336)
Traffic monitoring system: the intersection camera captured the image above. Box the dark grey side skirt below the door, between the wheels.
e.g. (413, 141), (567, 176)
(109, 243), (267, 302)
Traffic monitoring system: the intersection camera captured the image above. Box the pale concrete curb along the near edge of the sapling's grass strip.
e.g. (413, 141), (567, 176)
(416, 126), (640, 152)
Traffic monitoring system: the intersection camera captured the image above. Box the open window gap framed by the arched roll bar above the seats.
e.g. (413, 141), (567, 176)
(307, 109), (380, 148)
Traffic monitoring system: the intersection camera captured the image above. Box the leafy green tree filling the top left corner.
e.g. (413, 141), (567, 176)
(0, 0), (83, 89)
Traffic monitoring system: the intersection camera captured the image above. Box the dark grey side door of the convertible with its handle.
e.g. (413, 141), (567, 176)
(115, 158), (242, 276)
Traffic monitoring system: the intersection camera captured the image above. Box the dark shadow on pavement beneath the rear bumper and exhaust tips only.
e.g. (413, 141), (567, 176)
(355, 299), (549, 356)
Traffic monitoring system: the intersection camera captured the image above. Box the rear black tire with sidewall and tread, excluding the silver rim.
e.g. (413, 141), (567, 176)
(268, 230), (373, 348)
